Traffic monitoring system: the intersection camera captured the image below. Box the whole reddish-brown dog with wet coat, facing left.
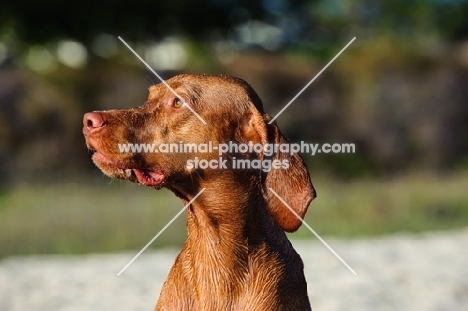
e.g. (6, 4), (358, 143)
(83, 74), (315, 311)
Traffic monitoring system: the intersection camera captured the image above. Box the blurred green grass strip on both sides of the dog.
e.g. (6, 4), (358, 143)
(0, 174), (468, 257)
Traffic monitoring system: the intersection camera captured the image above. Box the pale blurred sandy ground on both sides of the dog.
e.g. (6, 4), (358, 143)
(0, 229), (468, 311)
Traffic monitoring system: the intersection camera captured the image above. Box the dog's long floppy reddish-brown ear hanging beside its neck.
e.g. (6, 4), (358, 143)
(241, 110), (316, 232)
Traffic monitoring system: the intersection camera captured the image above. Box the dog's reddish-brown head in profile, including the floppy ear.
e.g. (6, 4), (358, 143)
(83, 74), (315, 231)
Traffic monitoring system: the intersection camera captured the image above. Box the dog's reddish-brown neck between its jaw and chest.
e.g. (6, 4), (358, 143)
(180, 171), (276, 245)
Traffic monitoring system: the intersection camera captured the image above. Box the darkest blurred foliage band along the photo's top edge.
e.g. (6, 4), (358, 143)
(0, 0), (468, 44)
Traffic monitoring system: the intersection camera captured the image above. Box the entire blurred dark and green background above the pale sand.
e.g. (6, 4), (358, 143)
(0, 0), (468, 256)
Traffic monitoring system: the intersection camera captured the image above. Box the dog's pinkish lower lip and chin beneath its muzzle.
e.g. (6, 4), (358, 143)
(93, 152), (166, 189)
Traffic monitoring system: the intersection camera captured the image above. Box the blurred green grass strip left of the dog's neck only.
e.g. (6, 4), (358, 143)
(0, 182), (185, 256)
